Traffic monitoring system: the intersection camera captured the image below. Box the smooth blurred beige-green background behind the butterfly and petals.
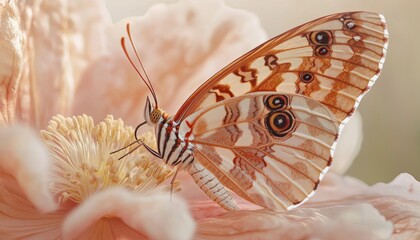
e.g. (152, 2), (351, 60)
(105, 0), (420, 184)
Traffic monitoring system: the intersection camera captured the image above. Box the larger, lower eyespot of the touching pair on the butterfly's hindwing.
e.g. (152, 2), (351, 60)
(265, 111), (295, 137)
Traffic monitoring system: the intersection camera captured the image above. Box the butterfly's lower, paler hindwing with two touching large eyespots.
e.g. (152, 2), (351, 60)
(180, 92), (339, 211)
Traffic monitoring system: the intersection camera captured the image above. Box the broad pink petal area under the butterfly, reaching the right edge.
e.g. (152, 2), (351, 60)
(189, 173), (420, 239)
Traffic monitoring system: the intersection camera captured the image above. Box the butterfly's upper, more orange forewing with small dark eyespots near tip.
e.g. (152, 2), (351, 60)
(174, 12), (388, 127)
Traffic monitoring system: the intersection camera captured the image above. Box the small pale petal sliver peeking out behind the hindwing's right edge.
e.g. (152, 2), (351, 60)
(330, 111), (363, 174)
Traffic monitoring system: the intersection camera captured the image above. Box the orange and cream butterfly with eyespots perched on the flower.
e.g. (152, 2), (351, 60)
(115, 12), (388, 211)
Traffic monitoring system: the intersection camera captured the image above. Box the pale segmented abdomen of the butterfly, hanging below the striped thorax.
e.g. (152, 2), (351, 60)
(188, 161), (239, 211)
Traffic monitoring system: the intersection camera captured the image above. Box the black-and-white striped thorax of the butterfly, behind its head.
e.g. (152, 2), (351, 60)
(156, 117), (194, 168)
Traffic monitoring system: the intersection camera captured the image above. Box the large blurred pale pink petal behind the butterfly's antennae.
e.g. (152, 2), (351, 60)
(76, 0), (266, 124)
